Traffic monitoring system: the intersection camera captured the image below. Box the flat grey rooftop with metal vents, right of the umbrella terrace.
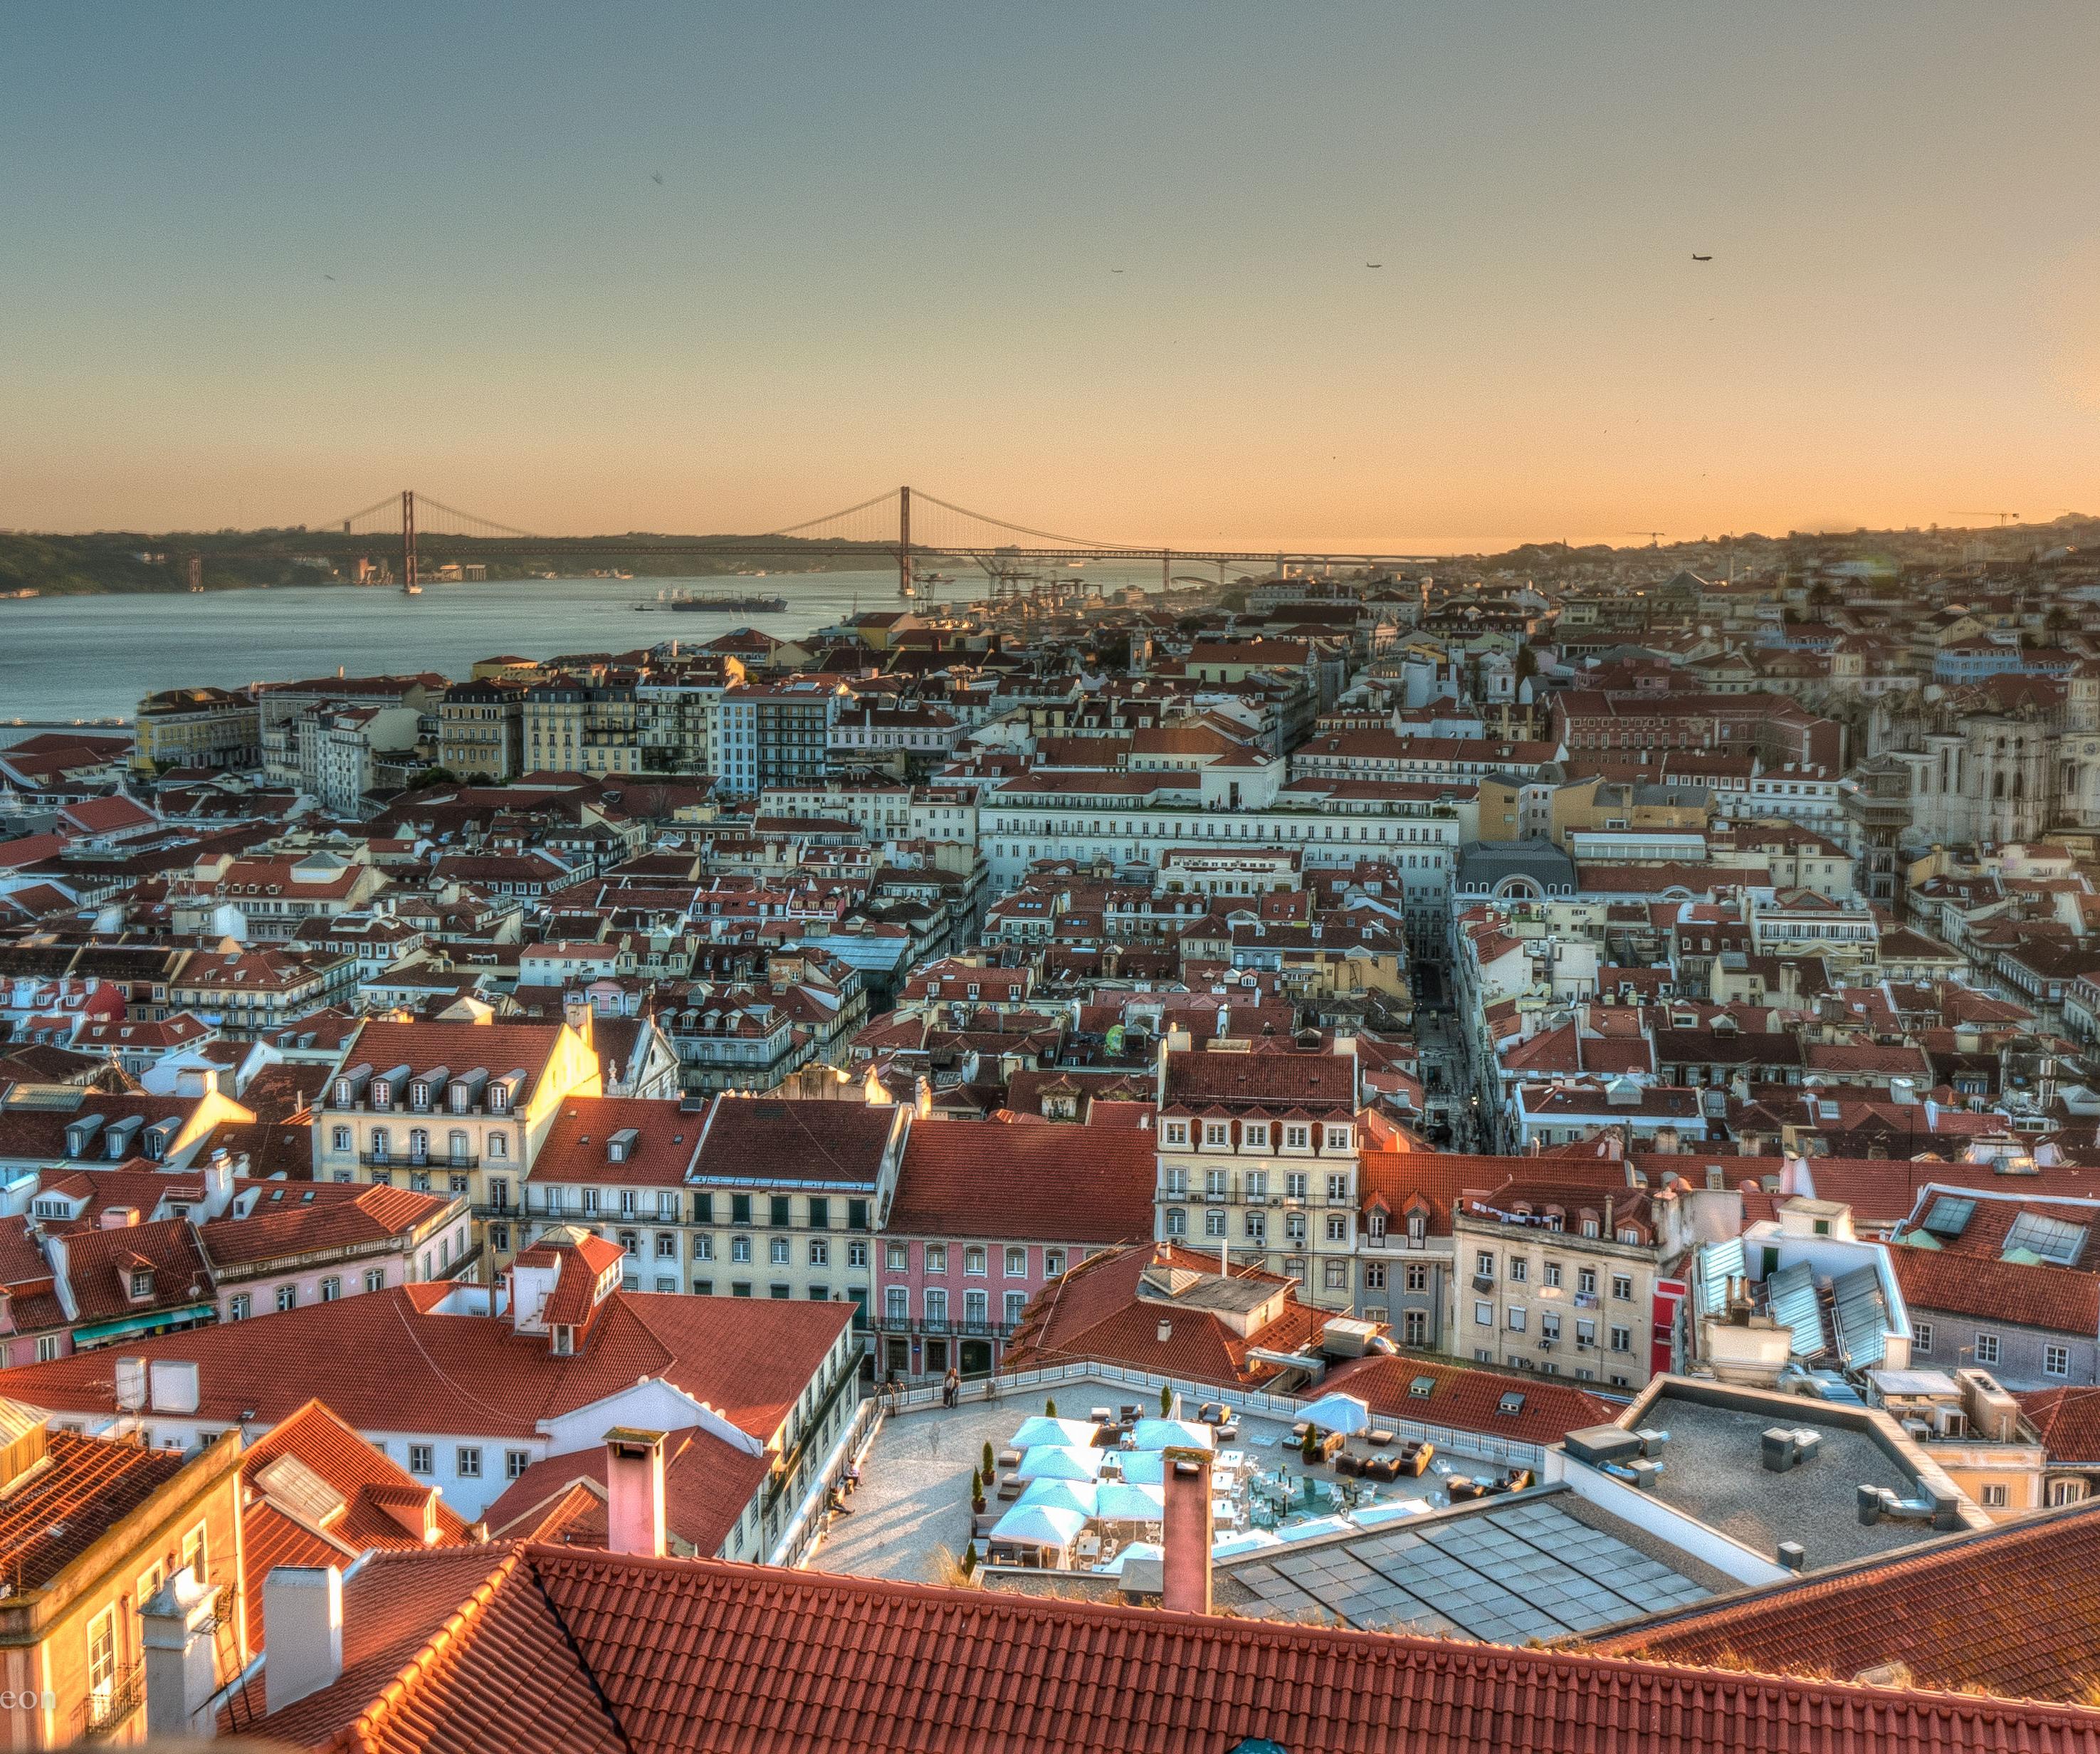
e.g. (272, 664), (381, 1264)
(1640, 1395), (1932, 1571)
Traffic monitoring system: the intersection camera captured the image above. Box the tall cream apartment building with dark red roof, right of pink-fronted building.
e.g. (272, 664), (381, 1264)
(1153, 1029), (1361, 1311)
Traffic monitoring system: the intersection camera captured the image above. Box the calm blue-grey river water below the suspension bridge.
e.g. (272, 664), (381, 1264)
(0, 567), (1159, 744)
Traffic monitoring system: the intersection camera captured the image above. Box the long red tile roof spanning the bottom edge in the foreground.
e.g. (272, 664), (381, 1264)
(241, 1546), (2100, 1754)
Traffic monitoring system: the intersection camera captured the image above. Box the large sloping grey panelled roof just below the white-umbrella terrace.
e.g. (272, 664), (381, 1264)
(1229, 1500), (1707, 1645)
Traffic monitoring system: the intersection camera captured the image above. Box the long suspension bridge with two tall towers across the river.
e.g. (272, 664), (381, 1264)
(189, 488), (1441, 597)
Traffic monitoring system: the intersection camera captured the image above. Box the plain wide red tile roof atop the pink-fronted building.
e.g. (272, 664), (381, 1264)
(886, 1103), (1157, 1244)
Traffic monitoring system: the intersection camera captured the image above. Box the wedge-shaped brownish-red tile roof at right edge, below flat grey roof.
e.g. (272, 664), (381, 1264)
(1592, 1504), (2100, 1701)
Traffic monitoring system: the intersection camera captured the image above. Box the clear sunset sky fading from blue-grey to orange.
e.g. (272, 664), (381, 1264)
(0, 0), (2100, 550)
